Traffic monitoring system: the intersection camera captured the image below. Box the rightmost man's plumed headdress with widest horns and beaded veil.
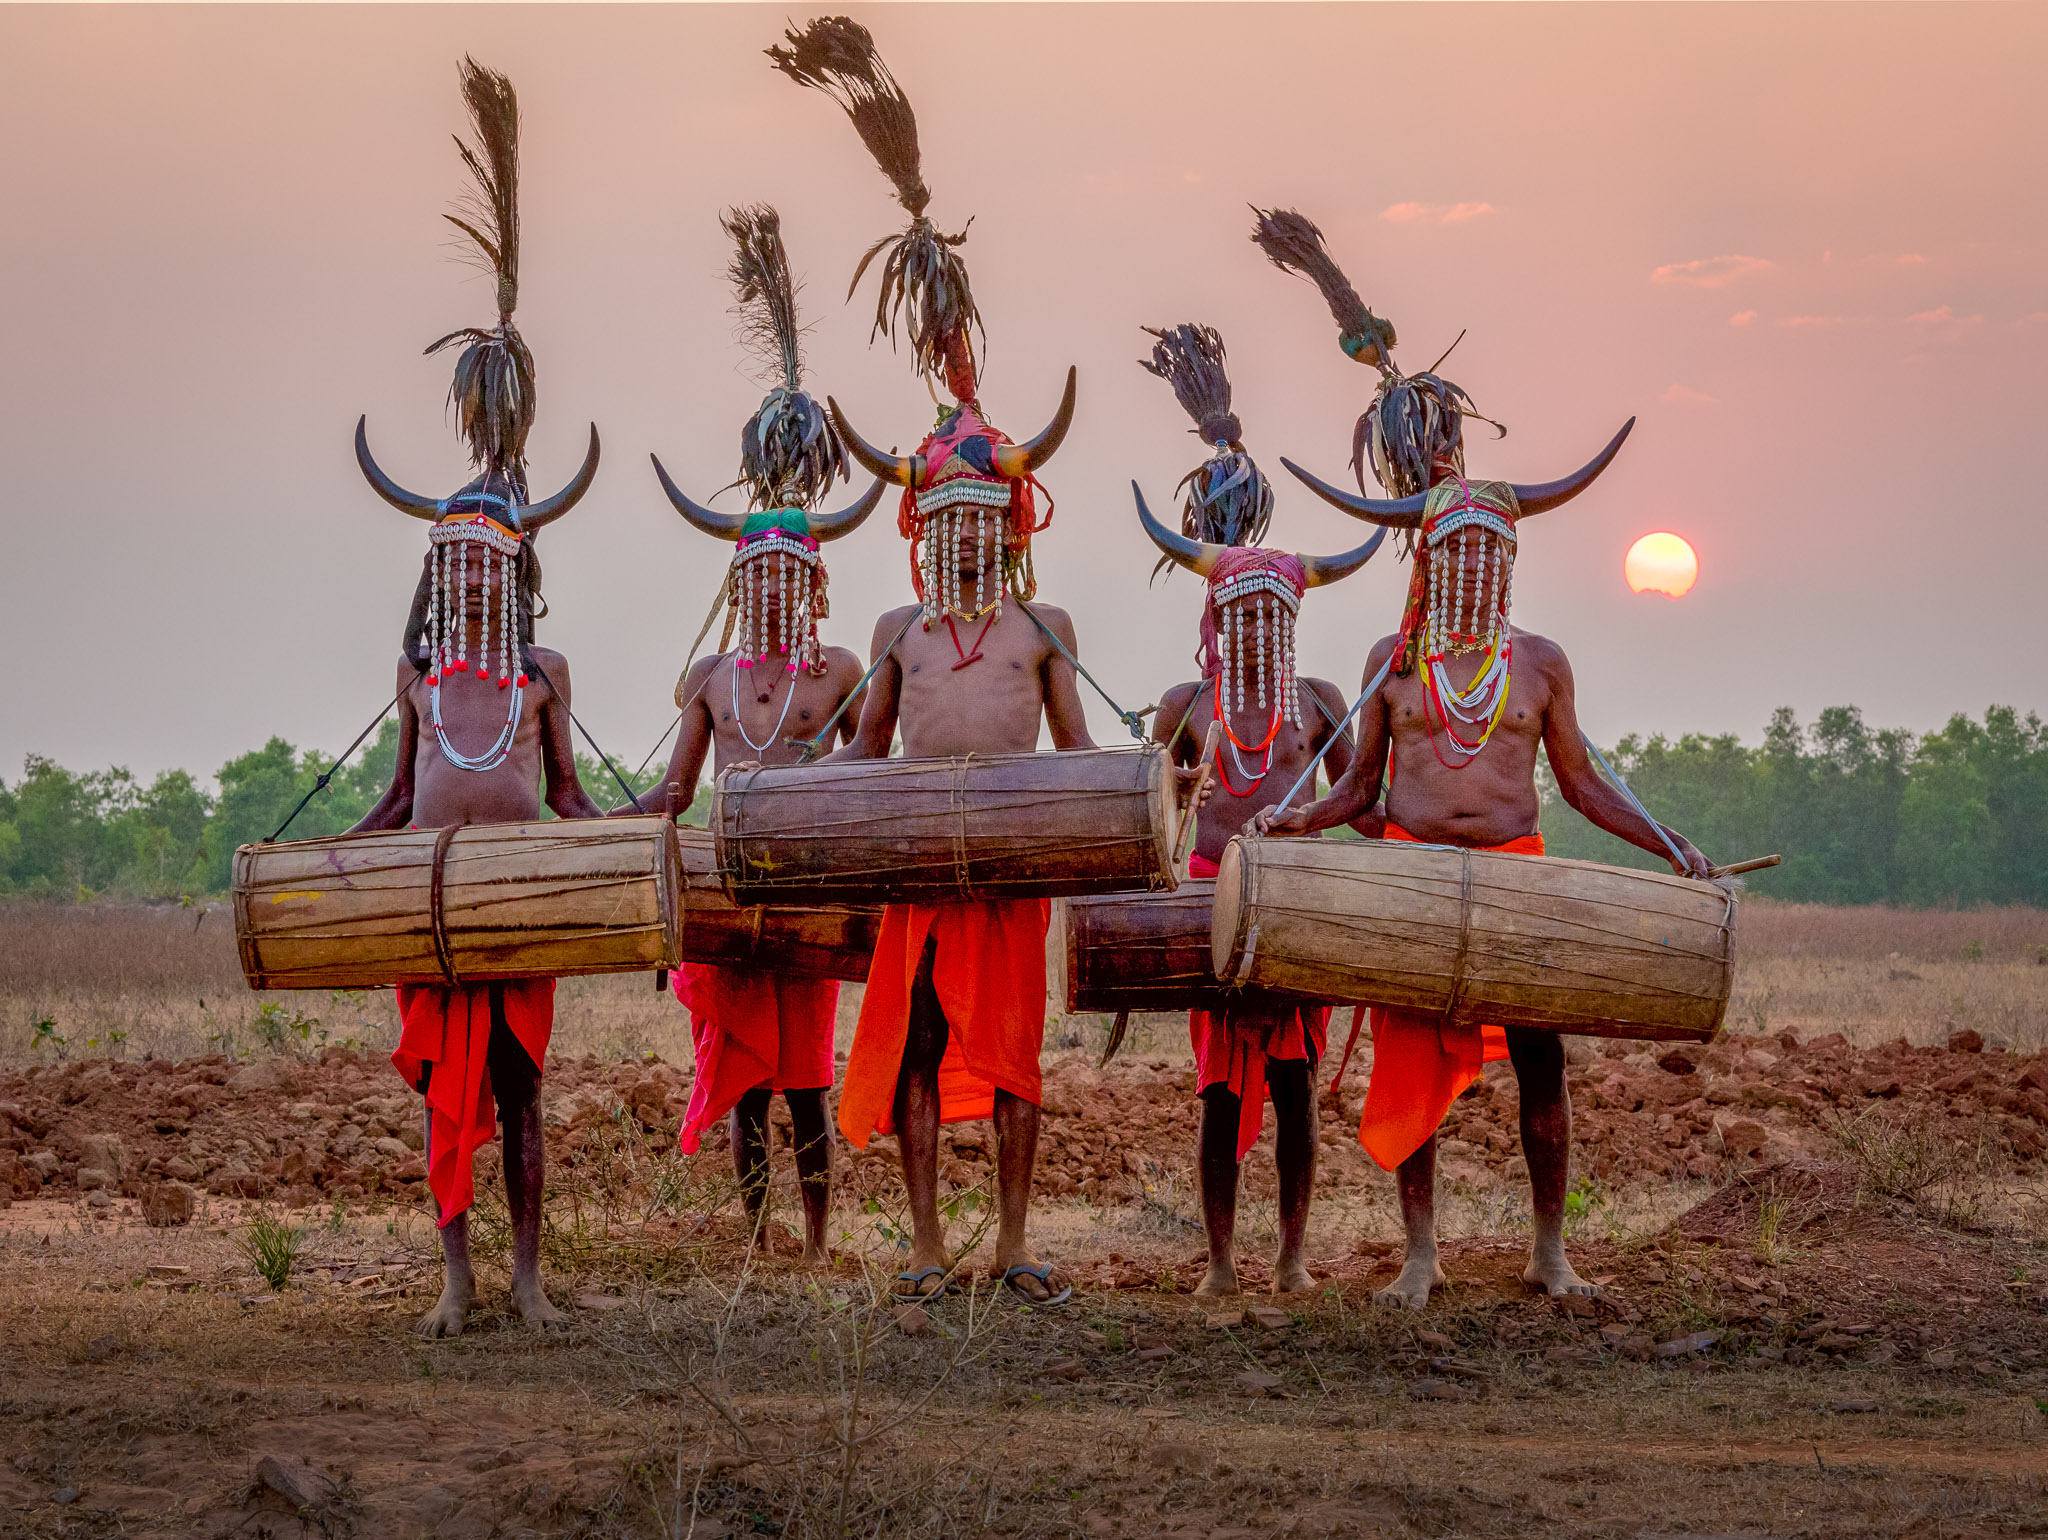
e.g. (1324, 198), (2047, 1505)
(1251, 209), (1636, 764)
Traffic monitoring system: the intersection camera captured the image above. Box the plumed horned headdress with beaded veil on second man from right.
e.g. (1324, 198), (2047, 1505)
(1130, 322), (1386, 754)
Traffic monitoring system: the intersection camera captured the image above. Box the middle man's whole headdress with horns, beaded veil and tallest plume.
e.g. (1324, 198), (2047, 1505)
(768, 16), (1075, 625)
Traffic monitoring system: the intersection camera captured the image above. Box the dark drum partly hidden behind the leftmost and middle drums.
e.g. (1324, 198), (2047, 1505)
(676, 827), (883, 979)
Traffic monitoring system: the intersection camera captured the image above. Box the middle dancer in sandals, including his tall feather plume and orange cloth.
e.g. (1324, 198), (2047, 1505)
(768, 16), (1094, 1304)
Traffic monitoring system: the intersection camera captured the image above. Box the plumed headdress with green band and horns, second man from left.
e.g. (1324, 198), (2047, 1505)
(649, 205), (883, 674)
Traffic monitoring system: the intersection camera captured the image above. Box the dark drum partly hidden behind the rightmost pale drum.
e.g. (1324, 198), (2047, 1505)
(1053, 876), (1225, 1012)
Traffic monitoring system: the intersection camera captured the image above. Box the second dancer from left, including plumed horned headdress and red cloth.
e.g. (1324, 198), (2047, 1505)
(638, 207), (883, 1261)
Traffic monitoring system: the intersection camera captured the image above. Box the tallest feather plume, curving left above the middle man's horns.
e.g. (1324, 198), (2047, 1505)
(768, 16), (981, 401)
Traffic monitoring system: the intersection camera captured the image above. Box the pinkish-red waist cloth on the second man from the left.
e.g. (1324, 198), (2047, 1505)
(670, 963), (840, 1155)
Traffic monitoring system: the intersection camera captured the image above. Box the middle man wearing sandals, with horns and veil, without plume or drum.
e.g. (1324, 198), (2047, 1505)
(829, 373), (1096, 1304)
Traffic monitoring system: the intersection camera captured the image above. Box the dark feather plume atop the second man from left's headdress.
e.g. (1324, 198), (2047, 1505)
(721, 205), (850, 508)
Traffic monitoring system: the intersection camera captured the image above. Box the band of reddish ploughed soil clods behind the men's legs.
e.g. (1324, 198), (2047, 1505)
(0, 1034), (2048, 1204)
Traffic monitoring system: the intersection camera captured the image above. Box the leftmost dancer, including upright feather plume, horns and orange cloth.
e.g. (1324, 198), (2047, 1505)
(356, 59), (602, 1337)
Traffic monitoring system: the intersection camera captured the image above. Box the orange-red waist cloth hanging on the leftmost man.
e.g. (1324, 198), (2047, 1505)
(391, 979), (555, 1227)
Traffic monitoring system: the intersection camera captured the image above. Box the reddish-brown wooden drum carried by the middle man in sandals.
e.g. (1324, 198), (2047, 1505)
(711, 745), (1176, 905)
